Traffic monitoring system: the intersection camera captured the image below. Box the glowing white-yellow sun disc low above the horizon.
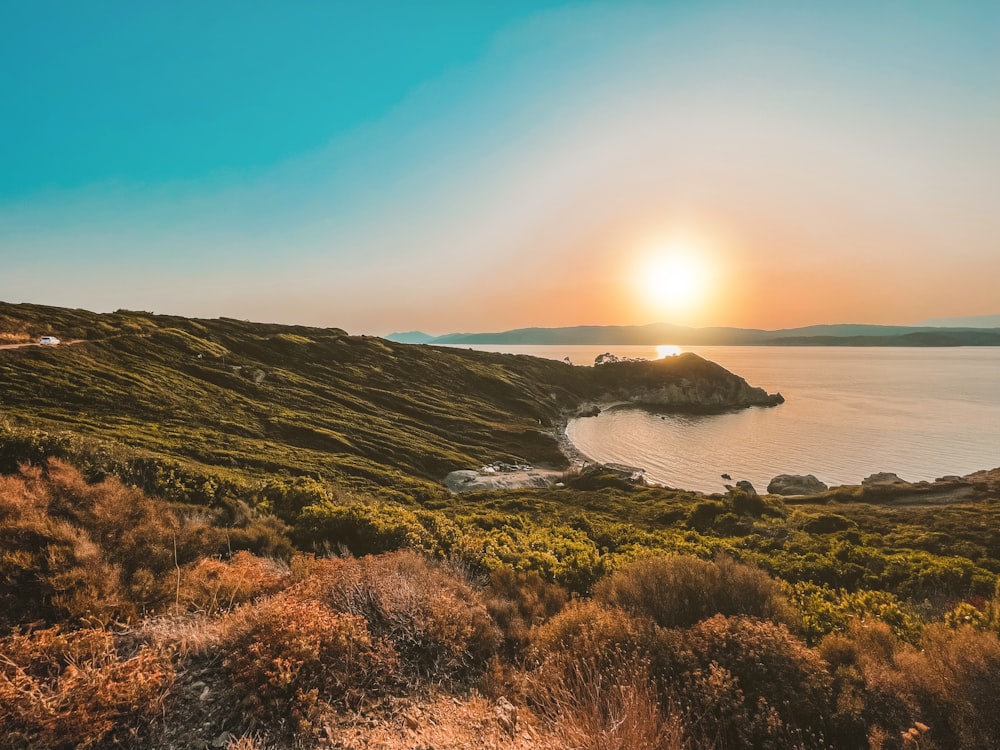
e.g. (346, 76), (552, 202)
(638, 245), (708, 314)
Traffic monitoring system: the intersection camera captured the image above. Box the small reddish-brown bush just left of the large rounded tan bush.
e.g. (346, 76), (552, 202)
(486, 567), (569, 656)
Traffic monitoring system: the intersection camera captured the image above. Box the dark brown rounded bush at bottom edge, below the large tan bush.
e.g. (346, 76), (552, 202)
(650, 615), (832, 750)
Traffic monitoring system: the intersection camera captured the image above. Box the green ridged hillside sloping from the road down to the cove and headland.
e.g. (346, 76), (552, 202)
(0, 304), (772, 502)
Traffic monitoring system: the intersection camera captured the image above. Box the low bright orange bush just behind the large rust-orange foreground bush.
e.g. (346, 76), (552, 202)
(172, 552), (288, 614)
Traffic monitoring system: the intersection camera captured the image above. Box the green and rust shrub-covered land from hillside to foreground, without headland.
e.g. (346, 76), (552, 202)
(0, 306), (1000, 750)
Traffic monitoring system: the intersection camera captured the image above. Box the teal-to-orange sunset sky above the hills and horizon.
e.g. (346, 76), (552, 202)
(0, 0), (1000, 335)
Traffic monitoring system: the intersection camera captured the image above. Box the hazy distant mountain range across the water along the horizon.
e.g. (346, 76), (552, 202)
(386, 316), (1000, 346)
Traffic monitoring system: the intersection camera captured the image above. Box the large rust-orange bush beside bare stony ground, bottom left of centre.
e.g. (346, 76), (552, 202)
(220, 590), (399, 733)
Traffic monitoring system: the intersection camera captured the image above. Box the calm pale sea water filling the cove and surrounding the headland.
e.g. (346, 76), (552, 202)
(446, 346), (1000, 492)
